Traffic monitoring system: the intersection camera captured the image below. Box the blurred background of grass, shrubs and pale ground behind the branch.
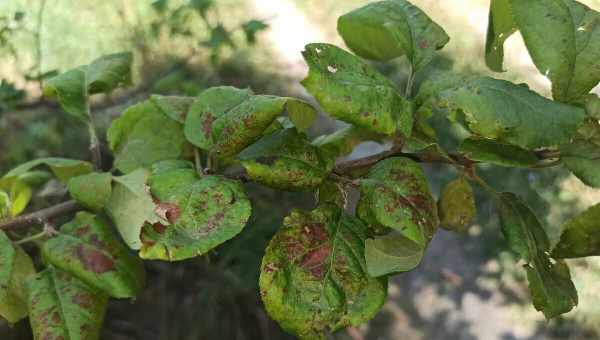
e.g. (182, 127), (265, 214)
(0, 0), (600, 340)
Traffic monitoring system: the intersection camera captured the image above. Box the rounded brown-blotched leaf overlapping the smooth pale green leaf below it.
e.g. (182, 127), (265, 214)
(357, 157), (439, 273)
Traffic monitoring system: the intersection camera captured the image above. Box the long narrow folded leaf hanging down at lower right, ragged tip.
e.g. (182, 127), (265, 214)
(498, 193), (577, 318)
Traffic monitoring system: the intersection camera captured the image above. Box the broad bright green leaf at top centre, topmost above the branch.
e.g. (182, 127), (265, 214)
(337, 0), (450, 70)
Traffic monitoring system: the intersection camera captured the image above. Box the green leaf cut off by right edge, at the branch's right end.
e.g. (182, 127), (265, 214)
(560, 119), (600, 188)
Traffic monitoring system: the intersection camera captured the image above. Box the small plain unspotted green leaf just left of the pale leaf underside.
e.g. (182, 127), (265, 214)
(67, 172), (112, 211)
